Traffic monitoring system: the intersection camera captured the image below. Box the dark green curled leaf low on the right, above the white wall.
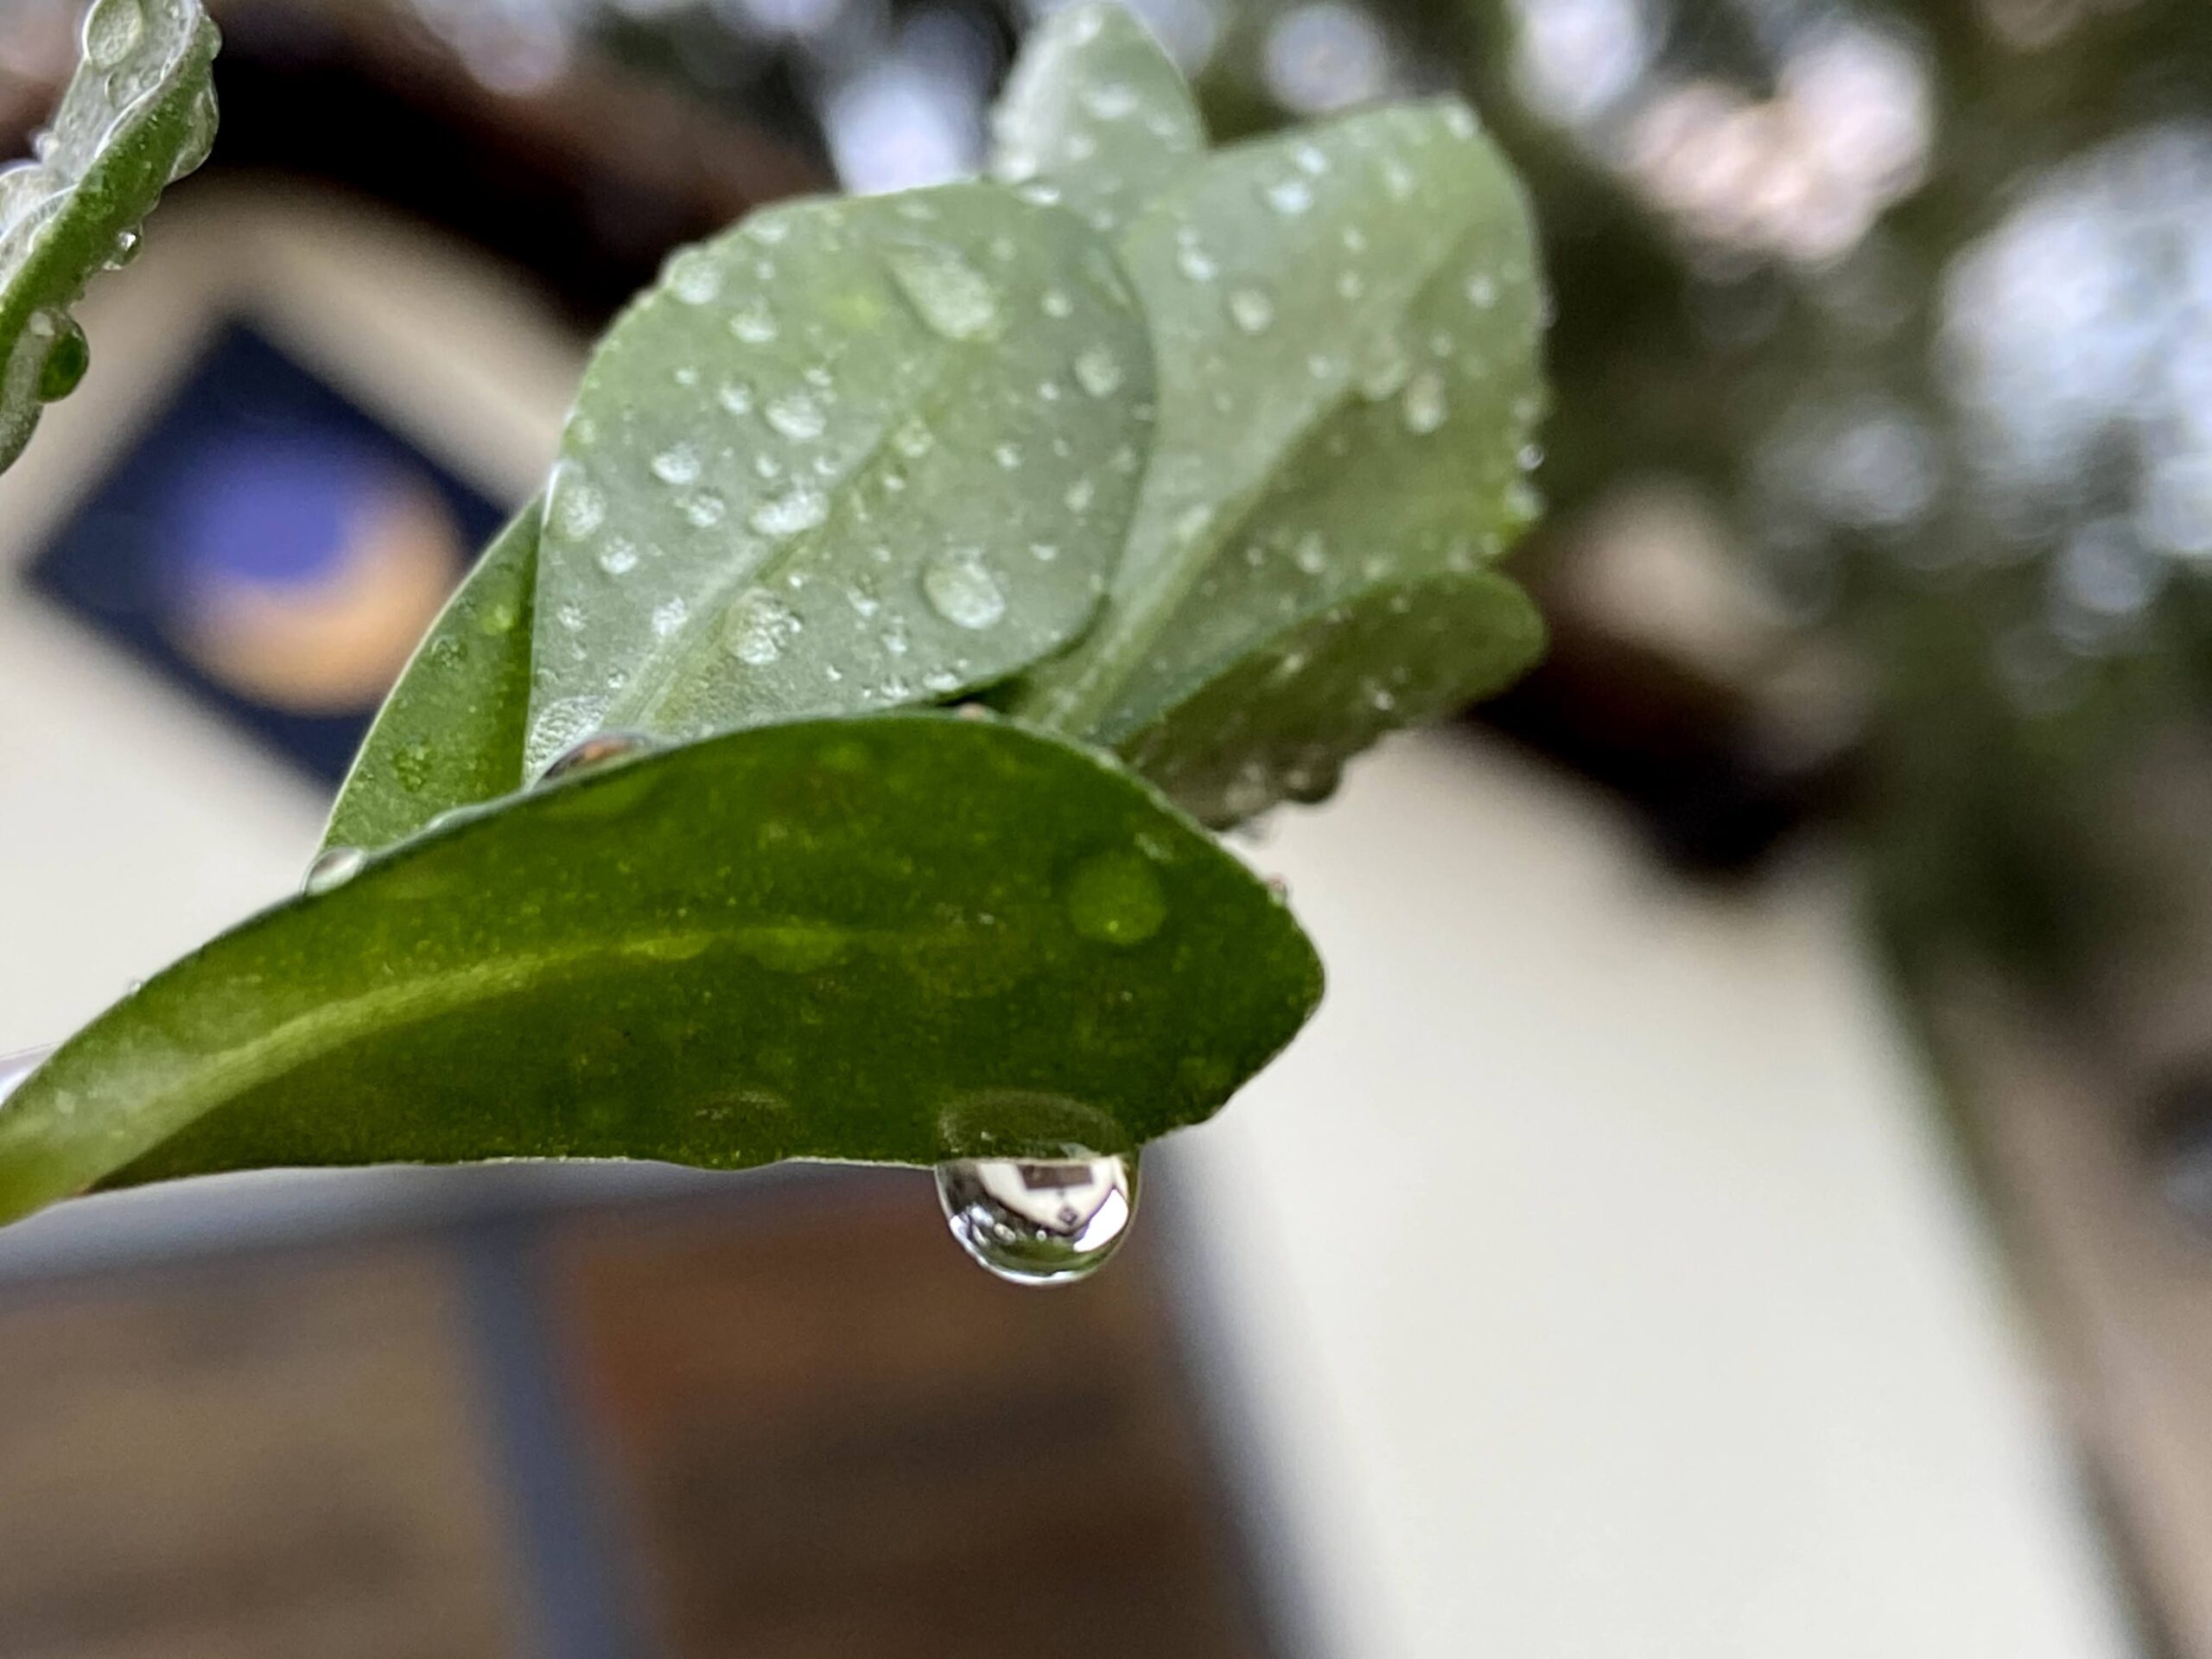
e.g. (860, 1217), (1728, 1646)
(1128, 570), (1544, 827)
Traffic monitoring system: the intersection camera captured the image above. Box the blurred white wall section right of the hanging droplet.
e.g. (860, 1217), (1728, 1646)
(1177, 734), (2126, 1659)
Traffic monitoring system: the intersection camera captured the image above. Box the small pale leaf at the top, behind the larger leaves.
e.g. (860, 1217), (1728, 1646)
(991, 4), (1205, 230)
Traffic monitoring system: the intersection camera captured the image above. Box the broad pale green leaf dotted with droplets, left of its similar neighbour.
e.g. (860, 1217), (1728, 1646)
(529, 183), (1153, 772)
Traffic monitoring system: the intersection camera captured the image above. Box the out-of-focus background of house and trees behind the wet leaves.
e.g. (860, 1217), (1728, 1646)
(0, 0), (2212, 1659)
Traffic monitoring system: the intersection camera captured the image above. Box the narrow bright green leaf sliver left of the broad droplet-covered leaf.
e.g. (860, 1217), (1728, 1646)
(323, 502), (542, 849)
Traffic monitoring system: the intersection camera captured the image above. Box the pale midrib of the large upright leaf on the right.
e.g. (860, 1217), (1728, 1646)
(1018, 207), (1476, 743)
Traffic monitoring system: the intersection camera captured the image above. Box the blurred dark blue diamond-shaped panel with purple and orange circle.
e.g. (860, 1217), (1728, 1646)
(29, 325), (505, 783)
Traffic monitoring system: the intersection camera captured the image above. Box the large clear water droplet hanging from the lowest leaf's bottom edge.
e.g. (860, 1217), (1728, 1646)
(938, 1157), (1137, 1285)
